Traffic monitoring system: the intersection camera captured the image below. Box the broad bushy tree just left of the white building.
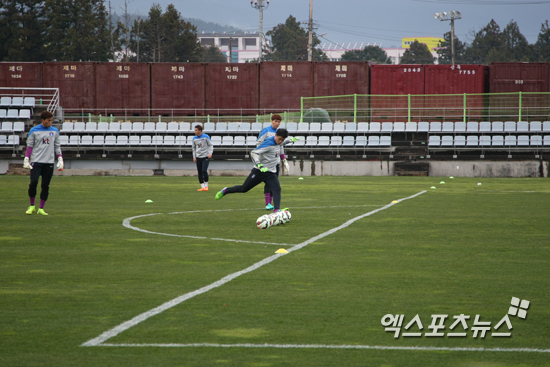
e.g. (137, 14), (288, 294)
(129, 4), (202, 62)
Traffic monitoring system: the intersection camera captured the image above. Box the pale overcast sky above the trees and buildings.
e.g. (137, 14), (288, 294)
(111, 0), (550, 47)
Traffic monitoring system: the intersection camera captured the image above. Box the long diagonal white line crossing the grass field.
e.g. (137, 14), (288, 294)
(81, 191), (426, 347)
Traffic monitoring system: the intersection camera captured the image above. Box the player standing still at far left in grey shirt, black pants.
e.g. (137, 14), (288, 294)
(23, 111), (63, 215)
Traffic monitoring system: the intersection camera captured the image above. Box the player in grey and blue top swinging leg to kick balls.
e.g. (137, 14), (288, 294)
(216, 129), (288, 212)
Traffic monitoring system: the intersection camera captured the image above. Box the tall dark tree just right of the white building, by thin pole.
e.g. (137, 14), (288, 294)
(266, 15), (328, 61)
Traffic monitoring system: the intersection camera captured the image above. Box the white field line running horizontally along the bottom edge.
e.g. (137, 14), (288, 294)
(99, 343), (550, 353)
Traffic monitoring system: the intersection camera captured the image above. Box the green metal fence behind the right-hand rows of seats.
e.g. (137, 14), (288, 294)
(301, 92), (550, 122)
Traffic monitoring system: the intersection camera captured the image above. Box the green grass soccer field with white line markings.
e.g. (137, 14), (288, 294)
(0, 176), (550, 367)
